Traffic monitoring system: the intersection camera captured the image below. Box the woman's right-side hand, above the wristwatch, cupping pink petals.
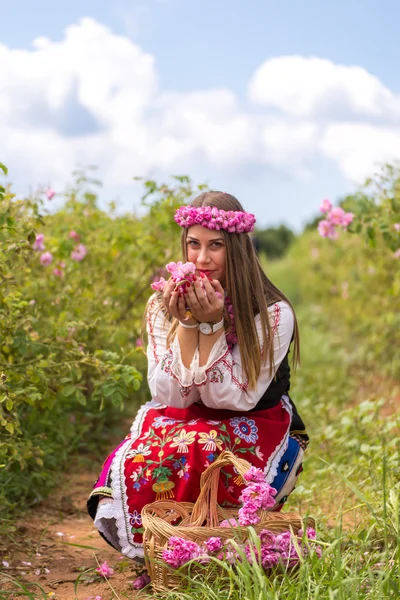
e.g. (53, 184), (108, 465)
(185, 276), (224, 323)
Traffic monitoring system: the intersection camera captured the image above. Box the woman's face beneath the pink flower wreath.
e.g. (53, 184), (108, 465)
(186, 225), (226, 286)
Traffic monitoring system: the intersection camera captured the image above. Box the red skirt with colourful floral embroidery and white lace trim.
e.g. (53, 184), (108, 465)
(88, 396), (298, 557)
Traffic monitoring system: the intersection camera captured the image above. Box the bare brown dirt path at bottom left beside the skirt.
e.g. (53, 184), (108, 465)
(0, 473), (143, 600)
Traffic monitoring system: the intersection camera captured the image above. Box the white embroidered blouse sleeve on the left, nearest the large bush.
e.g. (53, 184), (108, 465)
(147, 294), (199, 408)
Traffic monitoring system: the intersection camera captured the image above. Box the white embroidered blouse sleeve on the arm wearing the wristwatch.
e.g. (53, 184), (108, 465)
(195, 302), (294, 411)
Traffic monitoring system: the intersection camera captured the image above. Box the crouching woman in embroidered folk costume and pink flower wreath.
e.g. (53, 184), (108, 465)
(88, 192), (308, 558)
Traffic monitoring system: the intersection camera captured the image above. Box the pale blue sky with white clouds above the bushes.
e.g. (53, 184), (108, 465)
(0, 0), (400, 230)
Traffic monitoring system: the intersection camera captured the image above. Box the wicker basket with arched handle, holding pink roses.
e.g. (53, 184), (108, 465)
(142, 450), (315, 591)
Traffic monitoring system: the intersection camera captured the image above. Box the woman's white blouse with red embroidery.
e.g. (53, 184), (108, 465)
(147, 295), (294, 411)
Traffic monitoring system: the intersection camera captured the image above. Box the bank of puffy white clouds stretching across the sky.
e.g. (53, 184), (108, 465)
(0, 18), (400, 206)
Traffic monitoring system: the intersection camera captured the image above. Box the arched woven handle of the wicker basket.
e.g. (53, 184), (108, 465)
(190, 450), (251, 527)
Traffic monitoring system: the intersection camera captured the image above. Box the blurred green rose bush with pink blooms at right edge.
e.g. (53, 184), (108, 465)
(276, 161), (400, 378)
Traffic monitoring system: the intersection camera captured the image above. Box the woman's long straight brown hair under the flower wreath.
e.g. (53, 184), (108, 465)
(168, 191), (300, 389)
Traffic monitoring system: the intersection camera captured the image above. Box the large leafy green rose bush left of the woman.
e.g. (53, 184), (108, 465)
(0, 167), (206, 515)
